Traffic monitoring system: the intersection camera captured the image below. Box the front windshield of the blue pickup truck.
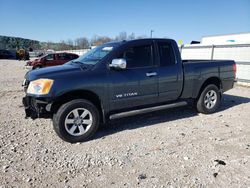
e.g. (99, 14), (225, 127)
(72, 44), (114, 65)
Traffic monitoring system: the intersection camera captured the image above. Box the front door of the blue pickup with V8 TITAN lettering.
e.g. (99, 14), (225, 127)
(109, 41), (158, 111)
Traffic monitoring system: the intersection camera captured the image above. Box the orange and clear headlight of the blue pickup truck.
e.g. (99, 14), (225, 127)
(27, 79), (54, 95)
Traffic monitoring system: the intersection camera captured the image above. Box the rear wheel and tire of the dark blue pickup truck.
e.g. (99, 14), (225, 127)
(196, 84), (221, 114)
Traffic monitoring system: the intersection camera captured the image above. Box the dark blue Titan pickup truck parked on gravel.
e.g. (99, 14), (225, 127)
(23, 39), (236, 143)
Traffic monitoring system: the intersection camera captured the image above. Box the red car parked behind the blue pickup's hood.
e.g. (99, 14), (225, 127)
(26, 52), (79, 69)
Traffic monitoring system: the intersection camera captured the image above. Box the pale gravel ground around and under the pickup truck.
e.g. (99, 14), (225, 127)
(0, 60), (250, 187)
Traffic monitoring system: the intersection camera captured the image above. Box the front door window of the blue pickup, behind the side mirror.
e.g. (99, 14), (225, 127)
(118, 45), (153, 68)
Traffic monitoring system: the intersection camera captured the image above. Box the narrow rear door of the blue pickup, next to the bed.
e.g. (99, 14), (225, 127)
(156, 41), (183, 102)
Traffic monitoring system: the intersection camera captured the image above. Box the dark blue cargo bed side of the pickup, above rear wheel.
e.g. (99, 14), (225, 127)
(182, 60), (236, 98)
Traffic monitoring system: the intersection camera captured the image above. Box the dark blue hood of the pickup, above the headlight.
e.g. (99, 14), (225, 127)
(25, 64), (83, 81)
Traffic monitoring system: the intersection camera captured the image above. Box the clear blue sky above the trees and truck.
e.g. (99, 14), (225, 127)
(0, 0), (250, 43)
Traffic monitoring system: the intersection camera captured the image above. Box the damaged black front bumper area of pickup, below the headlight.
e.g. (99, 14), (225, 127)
(23, 96), (52, 119)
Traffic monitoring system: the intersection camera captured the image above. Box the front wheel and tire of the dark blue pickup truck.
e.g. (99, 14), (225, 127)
(53, 99), (100, 143)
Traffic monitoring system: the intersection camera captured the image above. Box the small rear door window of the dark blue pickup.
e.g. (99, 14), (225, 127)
(158, 42), (175, 66)
